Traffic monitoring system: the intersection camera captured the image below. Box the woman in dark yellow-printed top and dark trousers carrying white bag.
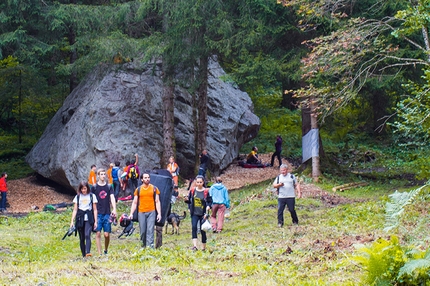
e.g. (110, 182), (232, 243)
(185, 175), (212, 251)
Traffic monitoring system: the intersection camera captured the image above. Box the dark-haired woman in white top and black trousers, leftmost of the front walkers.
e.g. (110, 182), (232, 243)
(70, 182), (98, 257)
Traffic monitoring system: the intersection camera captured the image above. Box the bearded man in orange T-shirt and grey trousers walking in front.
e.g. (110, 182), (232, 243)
(130, 172), (161, 248)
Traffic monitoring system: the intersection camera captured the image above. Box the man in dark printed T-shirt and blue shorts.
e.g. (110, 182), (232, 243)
(92, 169), (116, 255)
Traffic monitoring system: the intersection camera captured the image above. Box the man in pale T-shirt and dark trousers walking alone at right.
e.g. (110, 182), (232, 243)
(273, 164), (302, 227)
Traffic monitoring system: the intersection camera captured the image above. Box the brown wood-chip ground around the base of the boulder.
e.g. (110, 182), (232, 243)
(4, 154), (346, 214)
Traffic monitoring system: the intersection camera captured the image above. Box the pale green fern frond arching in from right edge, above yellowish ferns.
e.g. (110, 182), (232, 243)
(384, 181), (430, 232)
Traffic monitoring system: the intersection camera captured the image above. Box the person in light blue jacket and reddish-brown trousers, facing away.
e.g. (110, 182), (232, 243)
(209, 177), (230, 233)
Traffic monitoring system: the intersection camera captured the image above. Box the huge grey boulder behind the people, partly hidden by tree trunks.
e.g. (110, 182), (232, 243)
(26, 59), (260, 189)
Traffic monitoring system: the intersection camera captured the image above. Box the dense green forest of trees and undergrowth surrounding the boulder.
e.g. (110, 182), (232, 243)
(0, 0), (430, 285)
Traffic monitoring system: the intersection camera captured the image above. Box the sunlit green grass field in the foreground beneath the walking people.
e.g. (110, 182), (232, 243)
(0, 179), (396, 285)
